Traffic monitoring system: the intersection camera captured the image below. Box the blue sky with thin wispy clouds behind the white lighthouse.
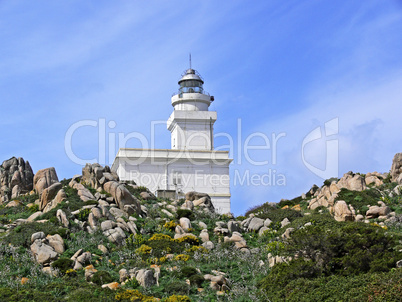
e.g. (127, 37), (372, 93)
(0, 0), (402, 215)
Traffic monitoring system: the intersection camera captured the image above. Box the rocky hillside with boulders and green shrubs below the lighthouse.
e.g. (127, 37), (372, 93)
(0, 153), (402, 302)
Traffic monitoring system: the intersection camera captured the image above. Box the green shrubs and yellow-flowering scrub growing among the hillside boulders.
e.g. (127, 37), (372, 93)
(0, 171), (402, 302)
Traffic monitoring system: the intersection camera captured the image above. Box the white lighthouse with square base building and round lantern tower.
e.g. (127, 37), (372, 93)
(112, 68), (232, 213)
